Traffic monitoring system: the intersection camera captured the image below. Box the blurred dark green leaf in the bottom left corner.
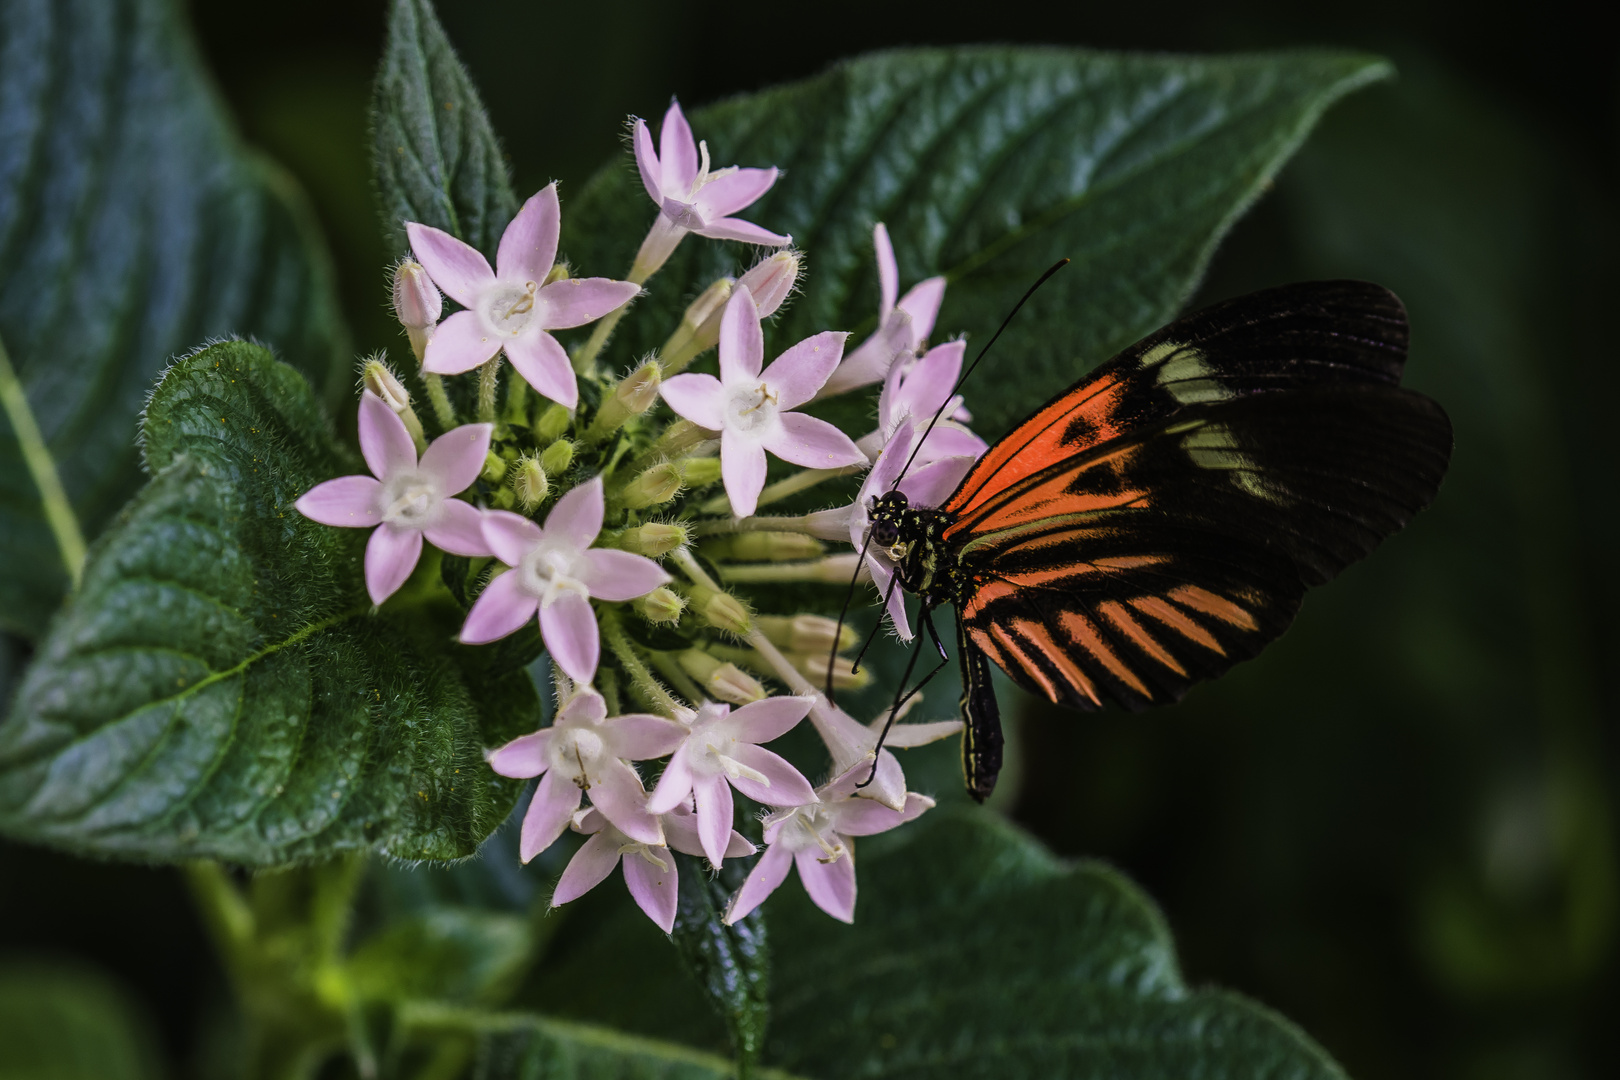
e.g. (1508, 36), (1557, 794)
(0, 963), (160, 1080)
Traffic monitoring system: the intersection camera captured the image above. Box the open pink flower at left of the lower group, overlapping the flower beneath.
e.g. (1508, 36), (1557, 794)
(489, 687), (687, 863)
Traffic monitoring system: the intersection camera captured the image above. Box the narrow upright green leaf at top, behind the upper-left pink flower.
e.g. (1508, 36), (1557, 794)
(371, 0), (517, 256)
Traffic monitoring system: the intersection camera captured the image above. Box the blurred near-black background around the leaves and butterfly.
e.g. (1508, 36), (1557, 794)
(0, 0), (1620, 1080)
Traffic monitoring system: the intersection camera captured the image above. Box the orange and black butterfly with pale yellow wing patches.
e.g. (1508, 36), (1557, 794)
(868, 282), (1452, 800)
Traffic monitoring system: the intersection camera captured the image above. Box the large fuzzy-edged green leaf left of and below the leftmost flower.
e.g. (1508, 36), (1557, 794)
(0, 342), (539, 866)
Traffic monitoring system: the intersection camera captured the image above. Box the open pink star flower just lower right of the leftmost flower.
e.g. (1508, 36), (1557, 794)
(462, 476), (671, 683)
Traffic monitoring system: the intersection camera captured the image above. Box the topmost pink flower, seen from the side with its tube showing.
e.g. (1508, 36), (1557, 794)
(630, 102), (794, 282)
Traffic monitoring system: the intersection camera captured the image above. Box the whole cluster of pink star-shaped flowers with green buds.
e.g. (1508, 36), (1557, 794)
(296, 104), (985, 931)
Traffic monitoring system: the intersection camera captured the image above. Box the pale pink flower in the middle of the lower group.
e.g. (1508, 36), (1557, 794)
(646, 698), (815, 866)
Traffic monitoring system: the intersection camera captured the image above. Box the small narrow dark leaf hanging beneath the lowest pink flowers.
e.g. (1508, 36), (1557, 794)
(671, 852), (771, 1069)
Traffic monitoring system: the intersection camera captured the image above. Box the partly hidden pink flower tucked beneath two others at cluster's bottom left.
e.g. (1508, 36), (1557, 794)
(551, 806), (755, 934)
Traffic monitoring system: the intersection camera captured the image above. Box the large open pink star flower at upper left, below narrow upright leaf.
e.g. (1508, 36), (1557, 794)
(405, 185), (642, 408)
